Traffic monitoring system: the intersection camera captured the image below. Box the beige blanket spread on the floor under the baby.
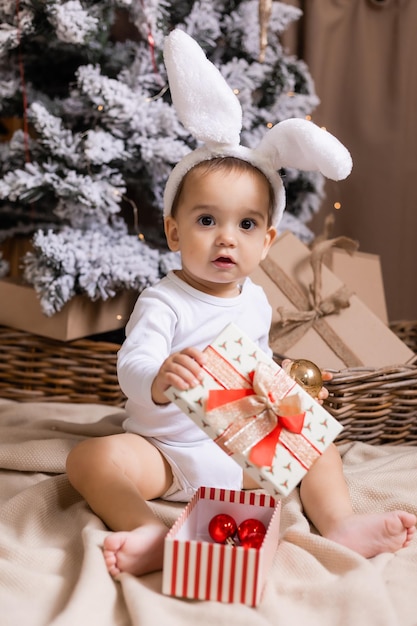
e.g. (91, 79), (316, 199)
(0, 399), (417, 626)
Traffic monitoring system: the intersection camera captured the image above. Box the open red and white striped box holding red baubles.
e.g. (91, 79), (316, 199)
(162, 487), (281, 606)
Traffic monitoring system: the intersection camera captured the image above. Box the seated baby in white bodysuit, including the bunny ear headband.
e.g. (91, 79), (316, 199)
(67, 30), (416, 576)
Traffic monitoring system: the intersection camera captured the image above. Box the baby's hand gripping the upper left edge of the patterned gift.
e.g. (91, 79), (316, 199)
(151, 348), (205, 404)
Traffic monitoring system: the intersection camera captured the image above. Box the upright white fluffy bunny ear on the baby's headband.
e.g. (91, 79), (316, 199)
(164, 29), (242, 146)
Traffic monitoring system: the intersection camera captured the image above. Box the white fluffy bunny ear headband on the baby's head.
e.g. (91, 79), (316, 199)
(164, 29), (352, 226)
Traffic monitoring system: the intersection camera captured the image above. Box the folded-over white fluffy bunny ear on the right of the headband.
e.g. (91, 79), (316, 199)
(256, 118), (352, 180)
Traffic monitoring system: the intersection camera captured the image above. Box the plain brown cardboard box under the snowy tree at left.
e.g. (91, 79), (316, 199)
(0, 278), (138, 341)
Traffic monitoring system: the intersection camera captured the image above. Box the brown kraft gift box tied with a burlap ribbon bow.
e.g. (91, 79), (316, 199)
(252, 232), (415, 370)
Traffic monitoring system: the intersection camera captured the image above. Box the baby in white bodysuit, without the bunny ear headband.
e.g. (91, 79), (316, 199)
(67, 157), (416, 576)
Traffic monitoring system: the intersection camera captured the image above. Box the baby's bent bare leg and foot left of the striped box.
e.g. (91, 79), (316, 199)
(67, 433), (172, 576)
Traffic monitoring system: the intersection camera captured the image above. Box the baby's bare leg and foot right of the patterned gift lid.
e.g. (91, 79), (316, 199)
(300, 445), (417, 558)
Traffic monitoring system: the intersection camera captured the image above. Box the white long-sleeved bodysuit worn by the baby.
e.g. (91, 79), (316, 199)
(118, 272), (271, 502)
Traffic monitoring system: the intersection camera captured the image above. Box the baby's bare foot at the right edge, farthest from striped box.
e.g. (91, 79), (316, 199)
(326, 511), (417, 558)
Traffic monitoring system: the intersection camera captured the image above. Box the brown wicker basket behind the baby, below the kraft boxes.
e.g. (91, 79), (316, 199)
(0, 322), (417, 445)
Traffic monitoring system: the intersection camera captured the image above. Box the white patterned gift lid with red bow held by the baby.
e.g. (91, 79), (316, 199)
(166, 324), (342, 497)
